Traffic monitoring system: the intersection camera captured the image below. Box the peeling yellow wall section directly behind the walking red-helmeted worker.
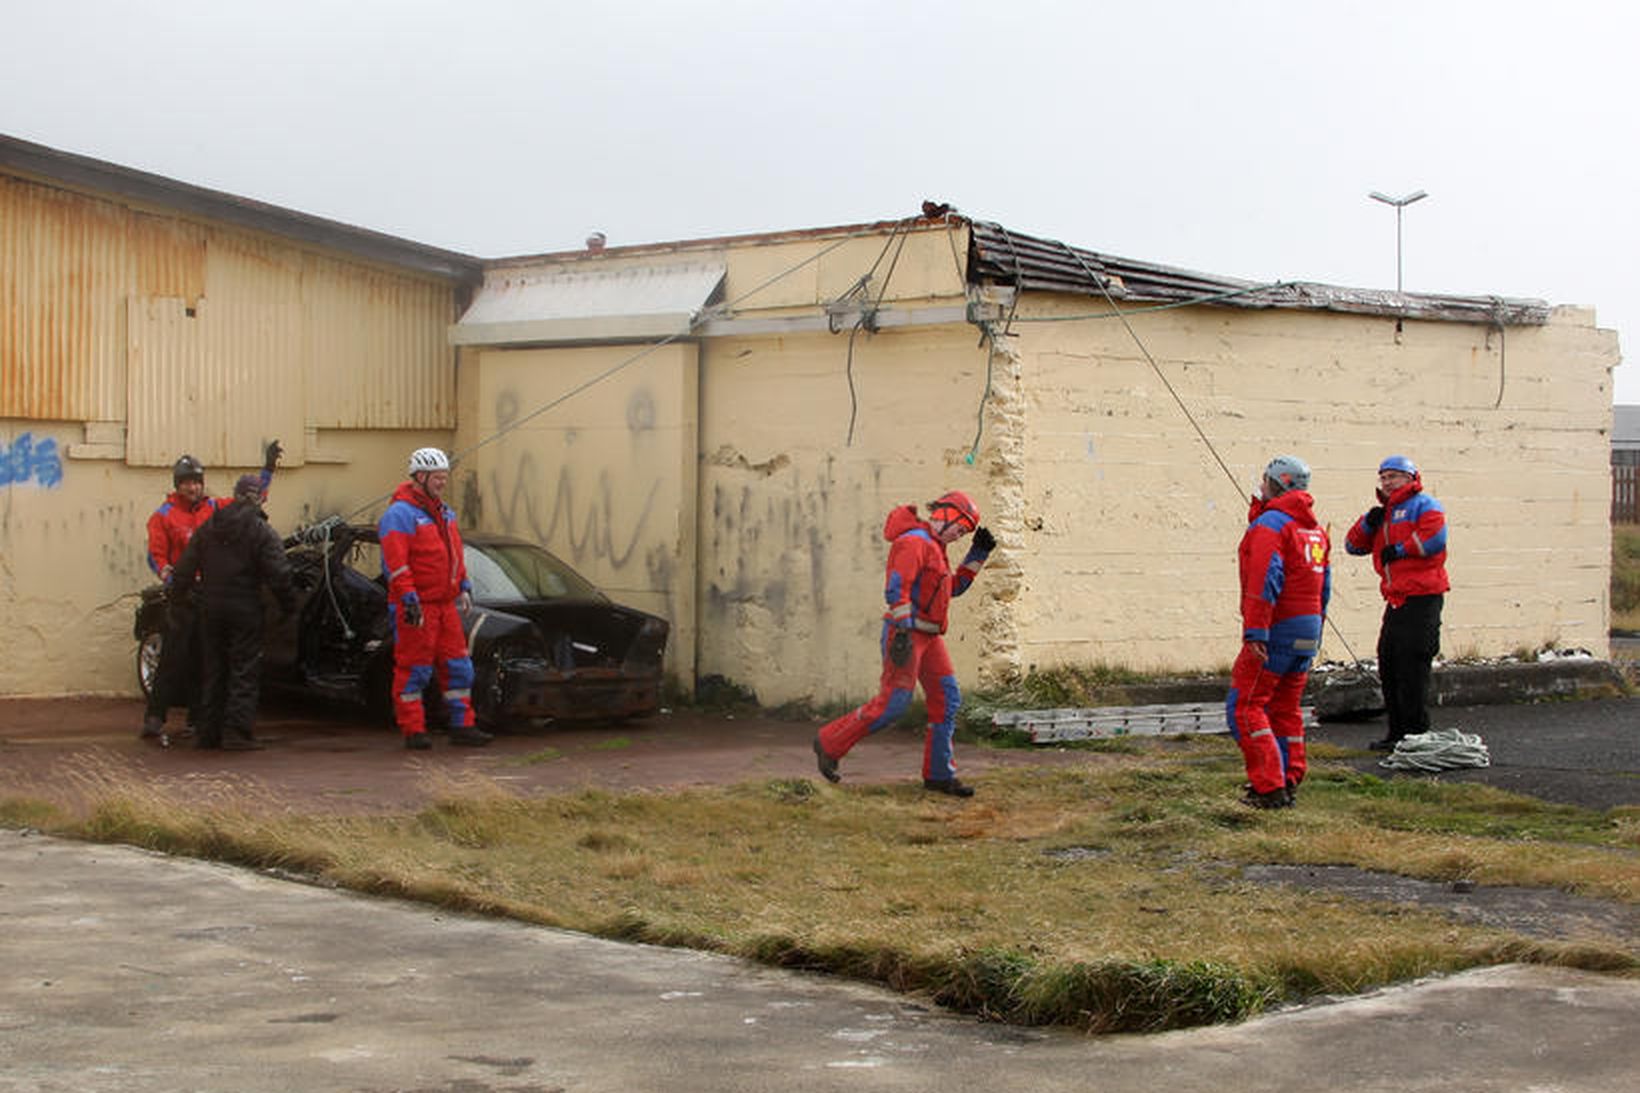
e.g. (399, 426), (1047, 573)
(699, 325), (994, 702)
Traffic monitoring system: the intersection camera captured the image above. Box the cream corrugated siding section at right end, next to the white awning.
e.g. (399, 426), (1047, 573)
(302, 254), (456, 428)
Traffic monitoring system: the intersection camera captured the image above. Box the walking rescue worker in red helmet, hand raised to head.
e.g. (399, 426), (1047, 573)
(813, 491), (997, 798)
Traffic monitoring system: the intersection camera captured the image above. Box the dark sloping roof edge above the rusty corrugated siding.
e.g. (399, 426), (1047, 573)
(0, 135), (484, 284)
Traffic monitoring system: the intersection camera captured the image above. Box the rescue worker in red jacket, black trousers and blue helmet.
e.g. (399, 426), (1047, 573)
(1343, 456), (1451, 752)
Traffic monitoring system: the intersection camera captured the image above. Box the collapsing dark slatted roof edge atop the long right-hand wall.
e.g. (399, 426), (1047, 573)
(968, 220), (1551, 327)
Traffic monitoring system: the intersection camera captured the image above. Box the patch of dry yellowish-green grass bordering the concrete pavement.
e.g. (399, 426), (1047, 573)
(0, 737), (1640, 1032)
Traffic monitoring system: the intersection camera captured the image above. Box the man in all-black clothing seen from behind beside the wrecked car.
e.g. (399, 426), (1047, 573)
(172, 474), (295, 752)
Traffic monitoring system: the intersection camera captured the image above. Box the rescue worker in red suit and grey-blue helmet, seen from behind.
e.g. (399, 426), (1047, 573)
(1225, 456), (1332, 809)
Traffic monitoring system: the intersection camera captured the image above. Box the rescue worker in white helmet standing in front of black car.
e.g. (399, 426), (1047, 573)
(376, 448), (490, 752)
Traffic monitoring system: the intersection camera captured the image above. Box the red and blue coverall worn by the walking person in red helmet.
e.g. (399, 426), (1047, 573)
(820, 505), (991, 781)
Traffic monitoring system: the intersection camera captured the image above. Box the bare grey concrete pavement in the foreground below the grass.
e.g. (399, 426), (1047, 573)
(0, 832), (1640, 1093)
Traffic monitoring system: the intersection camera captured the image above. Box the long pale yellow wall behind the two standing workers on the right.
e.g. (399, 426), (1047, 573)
(1015, 297), (1617, 670)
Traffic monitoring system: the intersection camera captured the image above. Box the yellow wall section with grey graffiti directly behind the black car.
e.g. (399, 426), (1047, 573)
(454, 345), (697, 679)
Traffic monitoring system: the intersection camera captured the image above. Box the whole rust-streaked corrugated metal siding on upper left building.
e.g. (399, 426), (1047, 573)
(0, 169), (456, 466)
